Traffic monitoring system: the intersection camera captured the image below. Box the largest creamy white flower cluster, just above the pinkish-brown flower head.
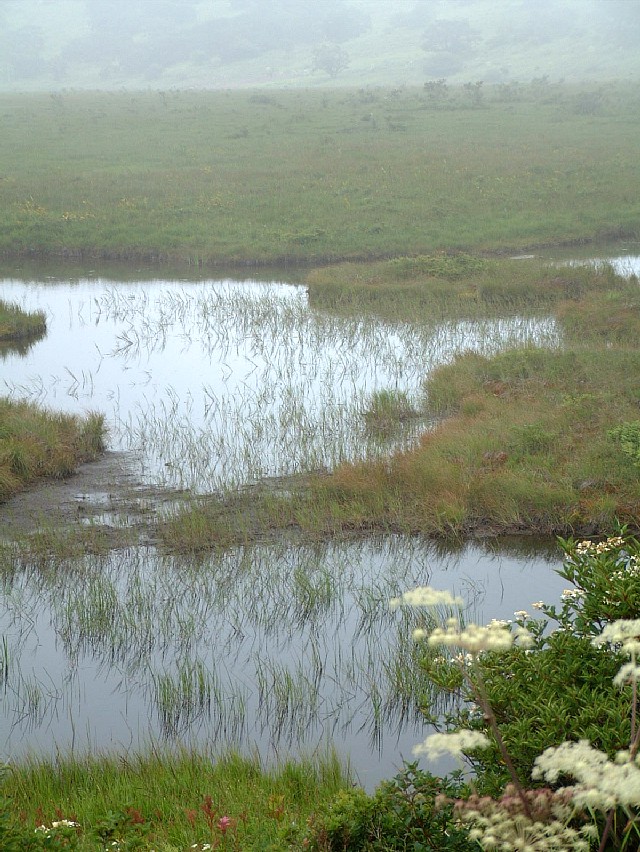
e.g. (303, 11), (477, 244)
(531, 740), (640, 812)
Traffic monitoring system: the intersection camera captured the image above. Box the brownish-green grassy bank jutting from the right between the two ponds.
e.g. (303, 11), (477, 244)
(158, 254), (640, 547)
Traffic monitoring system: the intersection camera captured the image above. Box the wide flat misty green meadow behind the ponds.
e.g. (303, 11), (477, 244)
(0, 84), (640, 265)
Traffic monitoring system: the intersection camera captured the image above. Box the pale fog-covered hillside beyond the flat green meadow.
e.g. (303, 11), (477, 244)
(0, 0), (640, 91)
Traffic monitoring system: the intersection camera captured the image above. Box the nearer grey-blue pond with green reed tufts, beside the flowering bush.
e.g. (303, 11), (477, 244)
(0, 536), (564, 783)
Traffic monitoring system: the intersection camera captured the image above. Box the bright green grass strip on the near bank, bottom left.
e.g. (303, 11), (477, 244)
(0, 751), (349, 852)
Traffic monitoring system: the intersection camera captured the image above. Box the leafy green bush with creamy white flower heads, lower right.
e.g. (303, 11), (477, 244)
(394, 528), (640, 852)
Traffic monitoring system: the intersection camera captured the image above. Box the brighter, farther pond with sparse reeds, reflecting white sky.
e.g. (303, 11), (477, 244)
(2, 279), (558, 492)
